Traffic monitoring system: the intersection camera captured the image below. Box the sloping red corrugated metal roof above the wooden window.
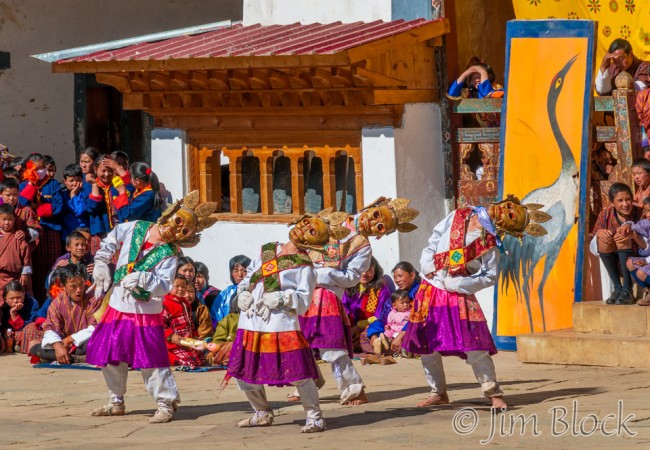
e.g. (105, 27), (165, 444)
(57, 19), (431, 63)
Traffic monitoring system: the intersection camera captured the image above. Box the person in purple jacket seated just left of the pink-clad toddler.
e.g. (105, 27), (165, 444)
(341, 257), (392, 353)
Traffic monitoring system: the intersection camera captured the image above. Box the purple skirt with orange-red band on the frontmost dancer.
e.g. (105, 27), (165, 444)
(228, 329), (319, 386)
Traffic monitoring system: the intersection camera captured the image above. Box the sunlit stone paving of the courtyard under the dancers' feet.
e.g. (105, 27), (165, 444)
(0, 352), (650, 449)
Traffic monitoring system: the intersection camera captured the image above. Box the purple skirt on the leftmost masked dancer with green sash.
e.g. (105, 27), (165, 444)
(86, 306), (169, 369)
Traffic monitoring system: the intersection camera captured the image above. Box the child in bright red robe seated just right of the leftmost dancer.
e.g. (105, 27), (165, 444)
(162, 273), (204, 368)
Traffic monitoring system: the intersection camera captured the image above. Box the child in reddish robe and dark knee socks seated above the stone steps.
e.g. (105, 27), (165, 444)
(589, 183), (643, 305)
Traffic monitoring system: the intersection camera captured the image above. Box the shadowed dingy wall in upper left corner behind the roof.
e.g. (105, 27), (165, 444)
(0, 0), (242, 172)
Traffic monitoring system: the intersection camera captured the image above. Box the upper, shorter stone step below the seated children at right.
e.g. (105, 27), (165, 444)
(573, 302), (650, 336)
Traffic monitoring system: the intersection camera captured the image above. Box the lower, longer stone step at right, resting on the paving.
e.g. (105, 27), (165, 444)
(517, 328), (650, 368)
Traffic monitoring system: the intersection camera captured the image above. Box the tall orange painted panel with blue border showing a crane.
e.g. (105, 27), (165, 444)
(493, 20), (594, 349)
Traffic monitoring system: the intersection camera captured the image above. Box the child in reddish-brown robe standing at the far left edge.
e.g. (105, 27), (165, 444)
(0, 204), (32, 290)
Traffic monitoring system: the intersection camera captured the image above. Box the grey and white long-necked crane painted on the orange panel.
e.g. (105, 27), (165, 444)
(500, 55), (579, 332)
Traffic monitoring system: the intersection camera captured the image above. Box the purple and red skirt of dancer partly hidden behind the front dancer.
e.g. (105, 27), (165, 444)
(299, 288), (353, 358)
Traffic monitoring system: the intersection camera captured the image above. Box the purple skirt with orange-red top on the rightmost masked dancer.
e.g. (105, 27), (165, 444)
(402, 281), (497, 359)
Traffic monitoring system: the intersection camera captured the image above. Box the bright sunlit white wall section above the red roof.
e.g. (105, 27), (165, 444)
(243, 0), (391, 25)
